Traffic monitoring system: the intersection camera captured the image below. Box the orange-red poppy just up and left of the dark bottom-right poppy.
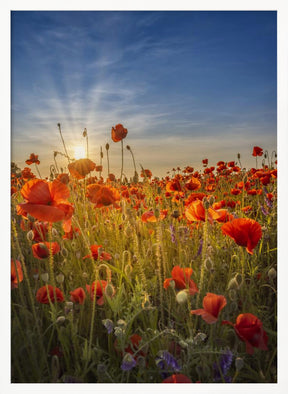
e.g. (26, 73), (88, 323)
(191, 293), (227, 324)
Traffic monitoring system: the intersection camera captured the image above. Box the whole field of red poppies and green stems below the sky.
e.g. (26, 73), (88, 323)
(11, 124), (277, 383)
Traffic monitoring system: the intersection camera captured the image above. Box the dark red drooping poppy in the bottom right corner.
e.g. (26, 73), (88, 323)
(222, 313), (268, 354)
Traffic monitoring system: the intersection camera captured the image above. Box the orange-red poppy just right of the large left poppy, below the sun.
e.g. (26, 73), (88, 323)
(86, 183), (120, 208)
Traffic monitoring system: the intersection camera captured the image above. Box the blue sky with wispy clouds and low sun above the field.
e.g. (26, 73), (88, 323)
(11, 11), (277, 176)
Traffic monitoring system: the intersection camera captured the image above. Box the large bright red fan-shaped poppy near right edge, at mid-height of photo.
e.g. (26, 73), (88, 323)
(221, 218), (262, 254)
